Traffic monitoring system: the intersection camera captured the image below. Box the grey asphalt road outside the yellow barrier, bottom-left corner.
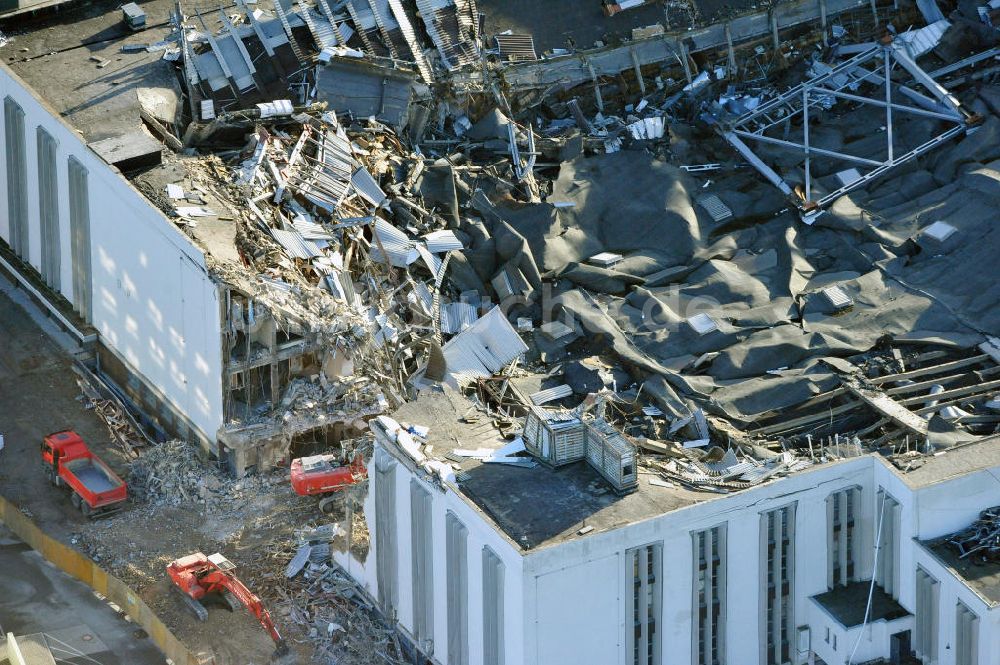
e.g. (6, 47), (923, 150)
(0, 524), (166, 665)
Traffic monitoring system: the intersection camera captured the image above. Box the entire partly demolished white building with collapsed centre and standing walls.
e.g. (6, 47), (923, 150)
(0, 0), (1000, 665)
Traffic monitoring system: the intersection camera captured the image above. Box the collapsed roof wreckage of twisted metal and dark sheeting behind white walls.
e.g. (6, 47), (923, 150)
(3, 0), (1000, 488)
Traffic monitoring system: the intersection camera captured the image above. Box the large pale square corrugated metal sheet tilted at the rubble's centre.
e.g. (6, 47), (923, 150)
(441, 307), (528, 385)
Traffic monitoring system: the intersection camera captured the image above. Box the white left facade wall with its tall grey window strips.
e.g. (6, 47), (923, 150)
(0, 67), (225, 442)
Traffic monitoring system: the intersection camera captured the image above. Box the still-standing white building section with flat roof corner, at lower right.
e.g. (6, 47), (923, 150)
(335, 393), (1000, 665)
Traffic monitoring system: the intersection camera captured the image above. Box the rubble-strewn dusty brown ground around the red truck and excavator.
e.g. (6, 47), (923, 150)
(0, 279), (384, 665)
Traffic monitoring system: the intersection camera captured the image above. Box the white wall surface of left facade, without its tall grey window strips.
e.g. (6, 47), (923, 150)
(0, 66), (222, 440)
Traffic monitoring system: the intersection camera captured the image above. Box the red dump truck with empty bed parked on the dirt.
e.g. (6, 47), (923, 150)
(42, 430), (128, 517)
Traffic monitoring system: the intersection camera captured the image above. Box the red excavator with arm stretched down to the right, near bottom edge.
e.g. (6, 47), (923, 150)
(167, 552), (295, 665)
